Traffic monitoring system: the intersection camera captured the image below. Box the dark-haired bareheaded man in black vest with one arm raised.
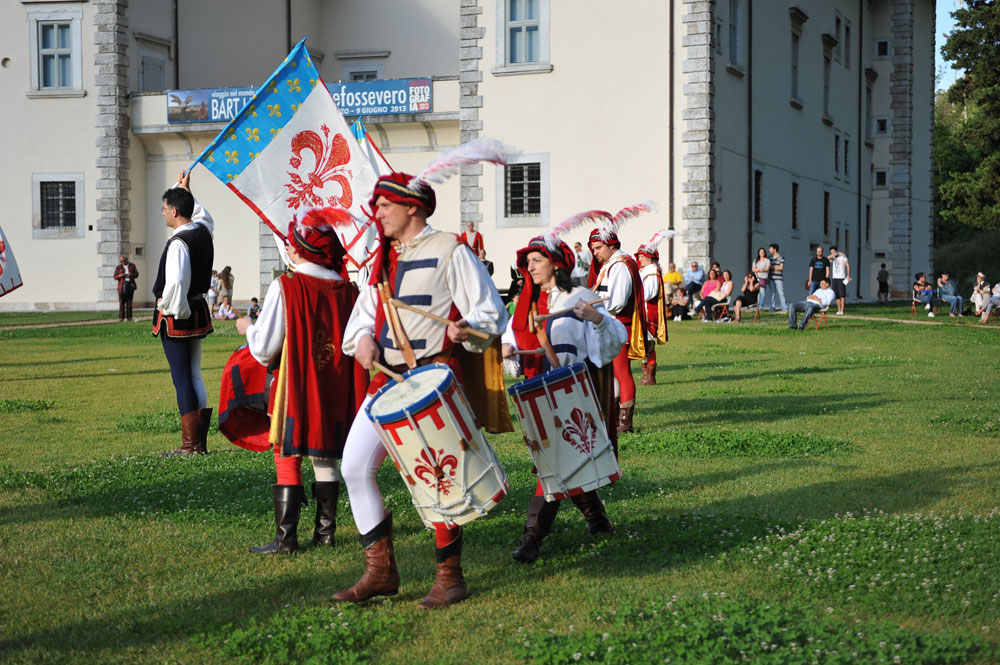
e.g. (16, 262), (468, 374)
(153, 171), (215, 455)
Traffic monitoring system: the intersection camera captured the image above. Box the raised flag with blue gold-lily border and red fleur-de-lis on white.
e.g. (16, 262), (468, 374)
(192, 39), (378, 268)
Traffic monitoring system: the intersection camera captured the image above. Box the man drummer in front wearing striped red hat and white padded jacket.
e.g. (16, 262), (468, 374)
(333, 173), (507, 608)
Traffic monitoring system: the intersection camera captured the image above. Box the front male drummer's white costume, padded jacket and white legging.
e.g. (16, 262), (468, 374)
(341, 225), (507, 534)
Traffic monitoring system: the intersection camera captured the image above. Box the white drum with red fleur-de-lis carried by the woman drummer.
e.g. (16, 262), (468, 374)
(507, 362), (622, 501)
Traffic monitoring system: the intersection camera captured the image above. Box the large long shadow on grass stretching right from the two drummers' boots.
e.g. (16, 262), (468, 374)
(470, 461), (982, 592)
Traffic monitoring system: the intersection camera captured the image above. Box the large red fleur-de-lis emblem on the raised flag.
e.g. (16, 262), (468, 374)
(285, 125), (354, 210)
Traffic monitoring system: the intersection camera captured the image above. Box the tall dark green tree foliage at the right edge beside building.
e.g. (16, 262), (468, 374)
(935, 0), (1000, 230)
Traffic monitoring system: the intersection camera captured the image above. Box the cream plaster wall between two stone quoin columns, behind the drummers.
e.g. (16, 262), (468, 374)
(479, 0), (680, 287)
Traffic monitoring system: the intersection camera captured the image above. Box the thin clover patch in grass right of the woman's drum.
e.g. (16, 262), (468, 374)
(628, 429), (856, 457)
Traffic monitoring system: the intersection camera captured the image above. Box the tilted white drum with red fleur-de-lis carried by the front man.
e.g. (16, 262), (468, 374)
(365, 364), (507, 527)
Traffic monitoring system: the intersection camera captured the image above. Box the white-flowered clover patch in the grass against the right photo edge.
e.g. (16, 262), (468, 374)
(720, 509), (1000, 621)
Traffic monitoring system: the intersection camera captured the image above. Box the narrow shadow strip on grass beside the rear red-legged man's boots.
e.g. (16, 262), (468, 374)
(636, 393), (891, 426)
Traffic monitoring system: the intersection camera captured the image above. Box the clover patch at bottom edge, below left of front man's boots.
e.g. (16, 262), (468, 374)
(203, 601), (410, 665)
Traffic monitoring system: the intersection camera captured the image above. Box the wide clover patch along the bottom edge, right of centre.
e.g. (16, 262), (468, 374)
(511, 592), (1000, 665)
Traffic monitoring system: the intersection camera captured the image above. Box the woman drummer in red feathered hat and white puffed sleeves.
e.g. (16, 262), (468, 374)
(501, 233), (627, 563)
